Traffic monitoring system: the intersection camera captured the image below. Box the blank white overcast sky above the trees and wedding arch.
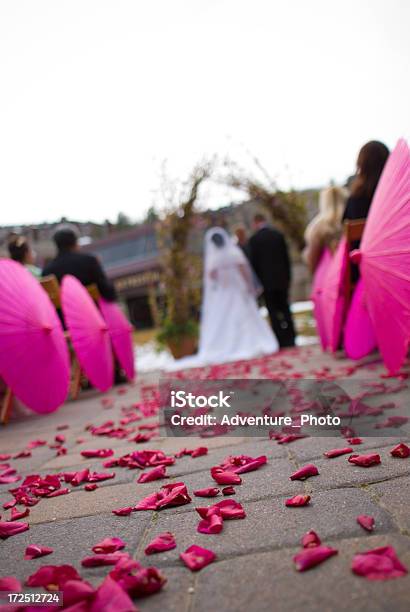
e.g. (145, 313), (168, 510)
(0, 0), (410, 225)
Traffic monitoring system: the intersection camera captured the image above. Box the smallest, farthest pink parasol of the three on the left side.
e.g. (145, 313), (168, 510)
(98, 298), (135, 380)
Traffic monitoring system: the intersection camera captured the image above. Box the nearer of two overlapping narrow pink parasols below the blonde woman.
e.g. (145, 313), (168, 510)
(322, 237), (348, 352)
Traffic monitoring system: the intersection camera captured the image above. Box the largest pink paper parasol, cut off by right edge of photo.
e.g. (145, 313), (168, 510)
(352, 140), (410, 373)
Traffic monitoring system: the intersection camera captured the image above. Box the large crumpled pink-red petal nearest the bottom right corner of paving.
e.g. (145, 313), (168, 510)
(352, 546), (407, 580)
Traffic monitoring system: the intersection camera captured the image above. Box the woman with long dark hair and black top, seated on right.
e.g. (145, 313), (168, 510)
(343, 140), (389, 222)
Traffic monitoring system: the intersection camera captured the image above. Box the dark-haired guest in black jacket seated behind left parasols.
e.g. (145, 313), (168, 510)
(43, 225), (116, 302)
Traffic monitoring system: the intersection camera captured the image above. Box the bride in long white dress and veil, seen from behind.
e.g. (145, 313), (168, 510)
(171, 227), (279, 370)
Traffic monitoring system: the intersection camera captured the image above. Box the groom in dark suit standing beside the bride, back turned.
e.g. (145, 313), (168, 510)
(249, 214), (295, 347)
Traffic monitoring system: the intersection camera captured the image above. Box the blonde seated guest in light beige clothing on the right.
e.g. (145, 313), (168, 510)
(303, 187), (347, 274)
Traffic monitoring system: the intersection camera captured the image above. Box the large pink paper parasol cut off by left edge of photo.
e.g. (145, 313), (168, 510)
(0, 259), (70, 414)
